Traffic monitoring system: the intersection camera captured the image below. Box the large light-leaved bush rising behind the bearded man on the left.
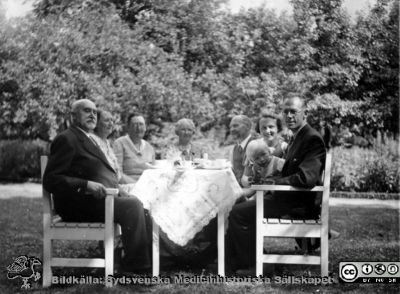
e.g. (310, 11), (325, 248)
(1, 2), (216, 139)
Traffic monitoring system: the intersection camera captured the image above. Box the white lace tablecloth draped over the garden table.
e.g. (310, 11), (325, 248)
(123, 168), (242, 246)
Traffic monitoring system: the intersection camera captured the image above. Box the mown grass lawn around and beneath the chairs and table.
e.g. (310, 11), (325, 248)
(0, 197), (400, 294)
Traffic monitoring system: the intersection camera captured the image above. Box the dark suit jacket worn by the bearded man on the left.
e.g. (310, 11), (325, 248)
(43, 126), (118, 221)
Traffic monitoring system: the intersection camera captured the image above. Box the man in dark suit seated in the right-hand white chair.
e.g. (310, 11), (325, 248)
(226, 97), (326, 270)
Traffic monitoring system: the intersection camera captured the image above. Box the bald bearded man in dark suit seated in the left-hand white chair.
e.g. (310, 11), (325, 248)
(43, 99), (150, 271)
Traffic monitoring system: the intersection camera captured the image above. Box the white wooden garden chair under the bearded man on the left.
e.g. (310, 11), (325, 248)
(40, 156), (121, 287)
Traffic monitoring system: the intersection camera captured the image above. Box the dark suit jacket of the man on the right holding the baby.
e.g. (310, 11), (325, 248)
(275, 124), (326, 217)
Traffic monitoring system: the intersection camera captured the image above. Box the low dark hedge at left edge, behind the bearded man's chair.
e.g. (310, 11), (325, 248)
(0, 140), (48, 181)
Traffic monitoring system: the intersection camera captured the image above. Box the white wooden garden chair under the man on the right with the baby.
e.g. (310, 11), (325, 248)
(251, 153), (332, 276)
